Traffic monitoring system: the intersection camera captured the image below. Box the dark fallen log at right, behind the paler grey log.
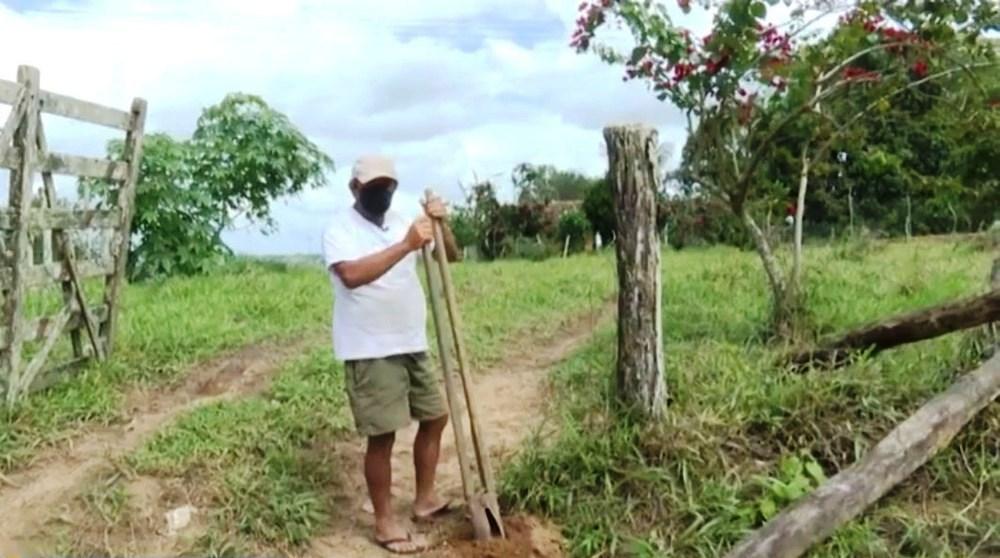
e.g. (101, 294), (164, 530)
(786, 289), (1000, 370)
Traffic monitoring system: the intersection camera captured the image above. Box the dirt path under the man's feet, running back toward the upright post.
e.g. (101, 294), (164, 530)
(305, 307), (613, 558)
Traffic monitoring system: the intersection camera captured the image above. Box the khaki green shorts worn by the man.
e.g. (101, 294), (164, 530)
(344, 353), (448, 436)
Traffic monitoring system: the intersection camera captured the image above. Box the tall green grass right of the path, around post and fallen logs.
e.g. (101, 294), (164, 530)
(502, 241), (1000, 557)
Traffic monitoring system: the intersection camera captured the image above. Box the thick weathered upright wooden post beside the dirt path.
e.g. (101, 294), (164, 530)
(604, 126), (666, 418)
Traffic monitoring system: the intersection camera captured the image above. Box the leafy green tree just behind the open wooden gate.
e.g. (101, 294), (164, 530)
(80, 94), (333, 279)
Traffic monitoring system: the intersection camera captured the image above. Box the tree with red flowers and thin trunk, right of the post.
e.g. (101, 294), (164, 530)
(571, 0), (998, 335)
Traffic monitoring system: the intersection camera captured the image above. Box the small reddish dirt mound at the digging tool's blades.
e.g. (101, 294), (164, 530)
(440, 516), (566, 558)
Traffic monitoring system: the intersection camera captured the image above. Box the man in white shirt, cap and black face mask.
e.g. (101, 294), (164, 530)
(323, 155), (458, 554)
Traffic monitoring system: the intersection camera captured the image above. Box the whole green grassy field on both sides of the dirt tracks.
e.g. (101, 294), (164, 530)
(0, 239), (1000, 557)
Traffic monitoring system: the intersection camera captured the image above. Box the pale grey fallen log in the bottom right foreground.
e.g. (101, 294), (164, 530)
(726, 356), (1000, 558)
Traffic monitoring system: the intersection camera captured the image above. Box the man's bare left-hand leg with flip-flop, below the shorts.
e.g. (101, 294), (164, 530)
(365, 433), (424, 552)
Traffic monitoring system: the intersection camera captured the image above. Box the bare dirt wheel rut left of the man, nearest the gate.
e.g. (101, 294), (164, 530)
(0, 338), (316, 549)
